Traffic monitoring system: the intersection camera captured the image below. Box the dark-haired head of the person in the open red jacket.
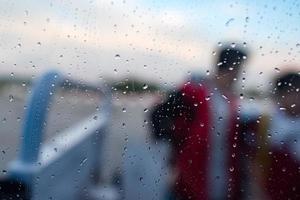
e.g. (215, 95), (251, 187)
(216, 43), (248, 89)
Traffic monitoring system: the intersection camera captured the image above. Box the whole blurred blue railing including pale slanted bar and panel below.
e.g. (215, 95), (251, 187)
(10, 72), (111, 199)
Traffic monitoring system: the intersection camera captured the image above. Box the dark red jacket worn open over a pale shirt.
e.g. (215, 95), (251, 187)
(169, 83), (242, 200)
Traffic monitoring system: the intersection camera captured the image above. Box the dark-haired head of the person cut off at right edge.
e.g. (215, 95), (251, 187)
(274, 72), (300, 117)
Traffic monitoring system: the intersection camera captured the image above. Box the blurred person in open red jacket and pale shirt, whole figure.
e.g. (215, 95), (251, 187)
(151, 43), (247, 200)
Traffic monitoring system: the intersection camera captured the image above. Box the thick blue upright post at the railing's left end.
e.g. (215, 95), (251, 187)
(20, 72), (62, 164)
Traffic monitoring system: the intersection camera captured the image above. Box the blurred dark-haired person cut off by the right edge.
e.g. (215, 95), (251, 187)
(255, 71), (300, 199)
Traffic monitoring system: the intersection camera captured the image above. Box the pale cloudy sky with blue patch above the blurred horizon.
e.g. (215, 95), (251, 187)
(0, 0), (300, 88)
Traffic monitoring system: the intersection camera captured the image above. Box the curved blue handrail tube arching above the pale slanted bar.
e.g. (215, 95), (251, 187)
(11, 71), (111, 183)
